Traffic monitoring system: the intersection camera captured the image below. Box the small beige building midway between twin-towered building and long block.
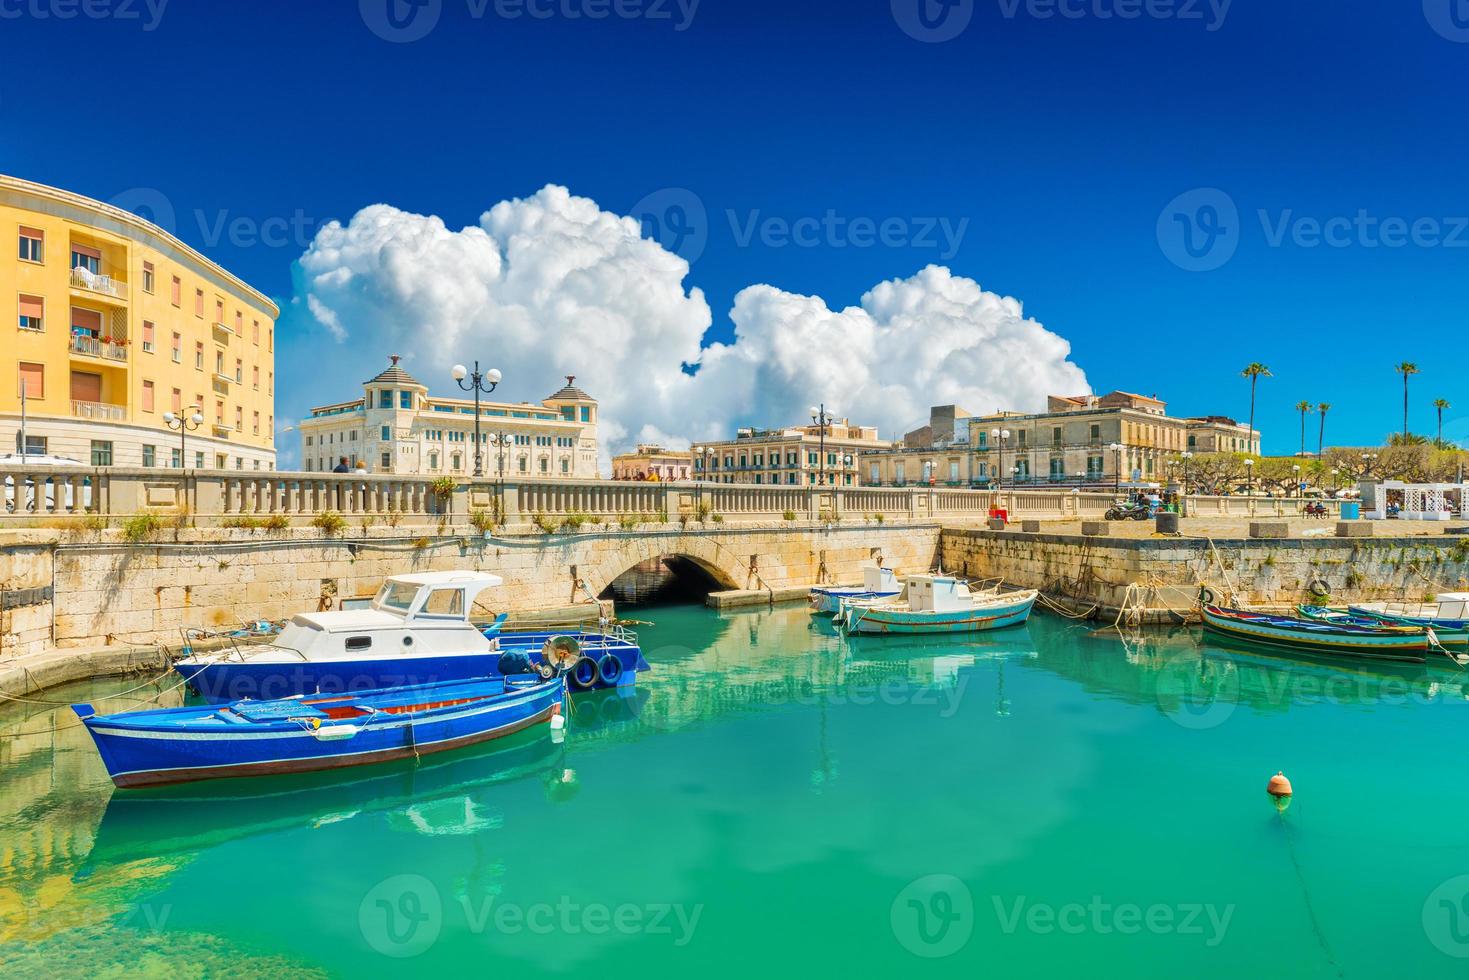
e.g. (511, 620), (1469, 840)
(692, 419), (893, 486)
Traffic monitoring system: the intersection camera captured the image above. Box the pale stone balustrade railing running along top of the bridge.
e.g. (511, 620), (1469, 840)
(0, 466), (1340, 526)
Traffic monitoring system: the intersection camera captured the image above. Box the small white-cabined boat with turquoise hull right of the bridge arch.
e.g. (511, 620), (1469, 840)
(842, 574), (1039, 633)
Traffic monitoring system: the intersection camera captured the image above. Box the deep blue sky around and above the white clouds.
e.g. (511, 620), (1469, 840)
(0, 0), (1469, 453)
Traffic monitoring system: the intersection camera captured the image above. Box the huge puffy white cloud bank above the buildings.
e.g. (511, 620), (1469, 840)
(282, 185), (1089, 473)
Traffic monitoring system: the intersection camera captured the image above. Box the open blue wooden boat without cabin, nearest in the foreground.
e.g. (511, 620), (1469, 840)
(72, 673), (566, 788)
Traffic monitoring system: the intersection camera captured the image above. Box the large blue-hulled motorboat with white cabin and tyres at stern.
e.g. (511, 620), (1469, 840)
(173, 572), (648, 704)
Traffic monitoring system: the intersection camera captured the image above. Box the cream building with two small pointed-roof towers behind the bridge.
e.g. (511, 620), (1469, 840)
(297, 364), (598, 479)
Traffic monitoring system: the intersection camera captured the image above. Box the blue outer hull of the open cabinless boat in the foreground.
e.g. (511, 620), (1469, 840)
(78, 680), (564, 788)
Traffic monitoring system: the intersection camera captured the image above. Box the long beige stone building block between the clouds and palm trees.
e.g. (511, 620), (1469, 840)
(862, 391), (1260, 486)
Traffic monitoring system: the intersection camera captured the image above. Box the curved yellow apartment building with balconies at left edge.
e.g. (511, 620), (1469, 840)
(0, 175), (278, 470)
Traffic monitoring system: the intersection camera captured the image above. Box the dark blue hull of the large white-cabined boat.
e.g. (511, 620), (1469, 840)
(173, 633), (648, 704)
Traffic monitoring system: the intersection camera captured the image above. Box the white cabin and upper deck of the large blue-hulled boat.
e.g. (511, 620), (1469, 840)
(250, 572), (504, 661)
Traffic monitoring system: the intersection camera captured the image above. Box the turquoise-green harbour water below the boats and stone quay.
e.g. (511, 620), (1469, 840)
(0, 607), (1469, 979)
